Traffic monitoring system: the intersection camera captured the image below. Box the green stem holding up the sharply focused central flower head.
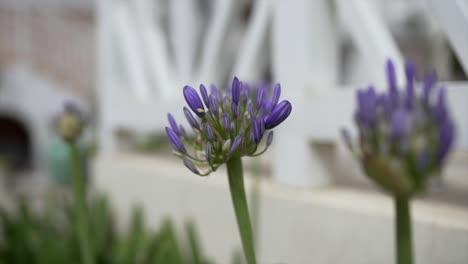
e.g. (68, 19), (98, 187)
(226, 158), (256, 264)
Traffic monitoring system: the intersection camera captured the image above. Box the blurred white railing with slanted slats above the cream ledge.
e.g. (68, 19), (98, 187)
(98, 0), (468, 186)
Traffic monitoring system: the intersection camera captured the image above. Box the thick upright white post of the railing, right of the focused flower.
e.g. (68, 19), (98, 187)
(272, 0), (337, 186)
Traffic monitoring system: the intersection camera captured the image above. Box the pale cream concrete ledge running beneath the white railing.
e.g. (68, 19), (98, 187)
(94, 154), (468, 264)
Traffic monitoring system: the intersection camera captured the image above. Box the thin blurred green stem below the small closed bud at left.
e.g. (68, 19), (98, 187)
(69, 143), (94, 264)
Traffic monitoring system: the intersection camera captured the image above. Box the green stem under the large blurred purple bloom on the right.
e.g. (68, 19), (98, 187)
(395, 196), (413, 264)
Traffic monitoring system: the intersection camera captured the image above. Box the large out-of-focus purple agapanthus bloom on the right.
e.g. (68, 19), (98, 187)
(342, 60), (455, 196)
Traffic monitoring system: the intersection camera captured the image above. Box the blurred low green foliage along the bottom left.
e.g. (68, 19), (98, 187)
(0, 195), (211, 264)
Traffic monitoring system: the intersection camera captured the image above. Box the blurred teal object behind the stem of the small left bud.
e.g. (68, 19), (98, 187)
(47, 137), (86, 187)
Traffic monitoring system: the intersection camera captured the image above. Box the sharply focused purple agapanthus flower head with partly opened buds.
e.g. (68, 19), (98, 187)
(166, 78), (292, 176)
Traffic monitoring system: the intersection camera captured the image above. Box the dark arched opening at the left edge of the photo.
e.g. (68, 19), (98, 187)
(0, 115), (32, 172)
